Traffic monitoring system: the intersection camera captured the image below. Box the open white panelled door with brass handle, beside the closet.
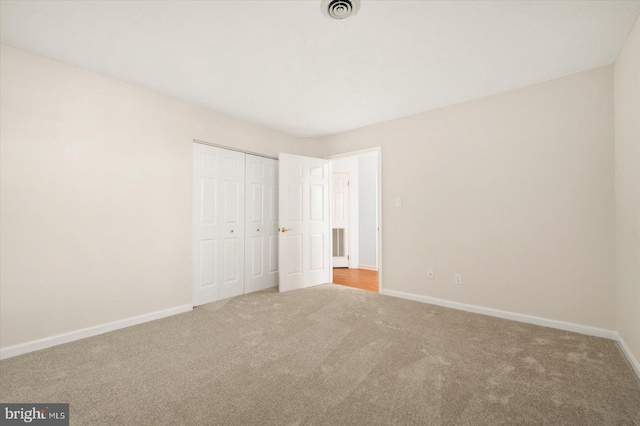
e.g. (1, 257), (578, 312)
(278, 154), (331, 292)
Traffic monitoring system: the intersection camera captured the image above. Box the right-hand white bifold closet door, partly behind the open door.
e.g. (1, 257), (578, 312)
(244, 154), (278, 293)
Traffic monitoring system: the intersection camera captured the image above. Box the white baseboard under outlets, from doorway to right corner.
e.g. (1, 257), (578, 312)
(382, 290), (618, 340)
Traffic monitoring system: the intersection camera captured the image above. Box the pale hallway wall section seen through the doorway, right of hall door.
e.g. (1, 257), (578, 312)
(358, 153), (378, 268)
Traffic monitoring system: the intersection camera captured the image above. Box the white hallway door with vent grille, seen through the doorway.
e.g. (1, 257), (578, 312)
(331, 172), (350, 268)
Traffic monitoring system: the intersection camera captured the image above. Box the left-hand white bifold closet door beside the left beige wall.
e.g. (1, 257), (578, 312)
(192, 143), (245, 305)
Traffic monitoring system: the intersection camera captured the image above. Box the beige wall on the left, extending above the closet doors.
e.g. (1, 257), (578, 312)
(0, 45), (314, 348)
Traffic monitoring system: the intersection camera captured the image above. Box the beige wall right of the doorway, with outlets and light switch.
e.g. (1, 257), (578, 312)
(319, 66), (616, 330)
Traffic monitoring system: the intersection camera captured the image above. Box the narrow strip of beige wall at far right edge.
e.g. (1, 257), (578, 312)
(614, 20), (640, 362)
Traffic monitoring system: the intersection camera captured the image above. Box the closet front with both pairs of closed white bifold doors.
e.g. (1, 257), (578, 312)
(192, 143), (278, 306)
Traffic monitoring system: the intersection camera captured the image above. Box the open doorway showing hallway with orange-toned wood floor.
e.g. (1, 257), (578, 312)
(330, 148), (380, 293)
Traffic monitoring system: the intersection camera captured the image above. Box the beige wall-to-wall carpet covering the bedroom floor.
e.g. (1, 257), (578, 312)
(0, 285), (640, 425)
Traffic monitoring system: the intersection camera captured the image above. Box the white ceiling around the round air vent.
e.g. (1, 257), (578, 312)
(0, 0), (640, 136)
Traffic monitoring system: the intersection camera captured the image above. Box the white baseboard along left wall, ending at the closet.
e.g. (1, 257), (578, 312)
(0, 305), (193, 359)
